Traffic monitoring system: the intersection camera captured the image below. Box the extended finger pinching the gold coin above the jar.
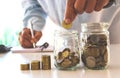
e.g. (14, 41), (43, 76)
(64, 0), (77, 24)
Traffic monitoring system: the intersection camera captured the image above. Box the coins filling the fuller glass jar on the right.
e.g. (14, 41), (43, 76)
(82, 34), (109, 69)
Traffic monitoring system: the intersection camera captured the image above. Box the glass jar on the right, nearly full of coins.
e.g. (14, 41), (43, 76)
(80, 23), (110, 69)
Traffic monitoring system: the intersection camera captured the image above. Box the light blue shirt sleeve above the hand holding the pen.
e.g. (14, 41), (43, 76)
(22, 0), (47, 31)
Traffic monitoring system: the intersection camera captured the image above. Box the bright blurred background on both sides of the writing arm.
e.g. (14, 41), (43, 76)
(0, 0), (59, 46)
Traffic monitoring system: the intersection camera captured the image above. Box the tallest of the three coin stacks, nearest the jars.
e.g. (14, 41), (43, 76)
(42, 55), (51, 70)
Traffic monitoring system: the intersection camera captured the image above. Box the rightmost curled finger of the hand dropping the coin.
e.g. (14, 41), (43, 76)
(95, 0), (109, 11)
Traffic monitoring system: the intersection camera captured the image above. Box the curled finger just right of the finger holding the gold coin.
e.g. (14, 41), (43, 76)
(74, 0), (86, 14)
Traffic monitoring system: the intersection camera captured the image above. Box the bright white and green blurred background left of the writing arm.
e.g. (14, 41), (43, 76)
(0, 0), (23, 46)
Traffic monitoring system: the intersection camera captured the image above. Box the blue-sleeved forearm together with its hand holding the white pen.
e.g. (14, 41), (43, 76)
(18, 0), (47, 48)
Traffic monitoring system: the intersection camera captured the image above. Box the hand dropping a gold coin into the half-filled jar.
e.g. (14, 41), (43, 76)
(64, 0), (109, 24)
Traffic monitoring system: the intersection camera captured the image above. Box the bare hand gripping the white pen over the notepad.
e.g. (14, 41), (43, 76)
(18, 28), (42, 48)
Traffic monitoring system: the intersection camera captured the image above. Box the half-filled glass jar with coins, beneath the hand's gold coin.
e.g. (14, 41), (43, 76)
(54, 30), (80, 70)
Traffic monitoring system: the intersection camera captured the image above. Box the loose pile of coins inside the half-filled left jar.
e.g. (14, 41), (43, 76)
(55, 48), (80, 69)
